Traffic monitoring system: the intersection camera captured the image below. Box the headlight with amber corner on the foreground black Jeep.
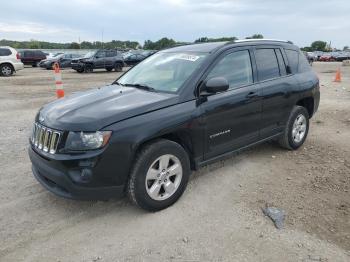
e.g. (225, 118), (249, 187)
(65, 131), (112, 151)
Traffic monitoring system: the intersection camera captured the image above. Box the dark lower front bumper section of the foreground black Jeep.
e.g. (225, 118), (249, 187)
(28, 146), (125, 200)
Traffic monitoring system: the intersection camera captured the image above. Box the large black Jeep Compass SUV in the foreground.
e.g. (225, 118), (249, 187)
(29, 40), (320, 211)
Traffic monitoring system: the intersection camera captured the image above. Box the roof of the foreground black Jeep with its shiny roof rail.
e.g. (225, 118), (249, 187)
(162, 39), (293, 53)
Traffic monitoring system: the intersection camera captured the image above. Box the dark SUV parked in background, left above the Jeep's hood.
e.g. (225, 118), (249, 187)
(71, 49), (124, 73)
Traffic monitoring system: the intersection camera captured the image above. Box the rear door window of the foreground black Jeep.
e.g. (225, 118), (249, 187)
(255, 49), (280, 81)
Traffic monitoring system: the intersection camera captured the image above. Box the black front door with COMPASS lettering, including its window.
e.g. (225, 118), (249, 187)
(201, 48), (262, 160)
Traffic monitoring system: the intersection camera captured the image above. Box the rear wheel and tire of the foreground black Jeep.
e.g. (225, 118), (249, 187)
(279, 106), (309, 150)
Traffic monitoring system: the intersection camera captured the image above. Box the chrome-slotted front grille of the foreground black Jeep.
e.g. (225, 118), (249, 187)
(31, 123), (62, 154)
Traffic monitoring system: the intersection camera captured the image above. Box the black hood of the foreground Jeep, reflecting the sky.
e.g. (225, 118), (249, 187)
(36, 85), (178, 131)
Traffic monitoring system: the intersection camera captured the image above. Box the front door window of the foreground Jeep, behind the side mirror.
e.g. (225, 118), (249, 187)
(207, 50), (253, 89)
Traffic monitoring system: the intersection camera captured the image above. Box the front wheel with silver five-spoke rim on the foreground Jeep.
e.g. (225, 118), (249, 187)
(128, 139), (191, 211)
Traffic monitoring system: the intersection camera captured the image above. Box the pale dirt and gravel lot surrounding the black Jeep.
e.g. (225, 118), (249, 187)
(0, 63), (350, 261)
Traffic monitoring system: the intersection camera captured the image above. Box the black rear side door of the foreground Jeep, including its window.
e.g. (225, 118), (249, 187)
(254, 46), (297, 139)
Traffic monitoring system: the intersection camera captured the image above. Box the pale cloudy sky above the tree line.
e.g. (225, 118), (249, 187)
(0, 0), (350, 48)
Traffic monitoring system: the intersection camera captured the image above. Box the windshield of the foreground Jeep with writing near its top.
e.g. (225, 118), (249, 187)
(118, 52), (207, 93)
